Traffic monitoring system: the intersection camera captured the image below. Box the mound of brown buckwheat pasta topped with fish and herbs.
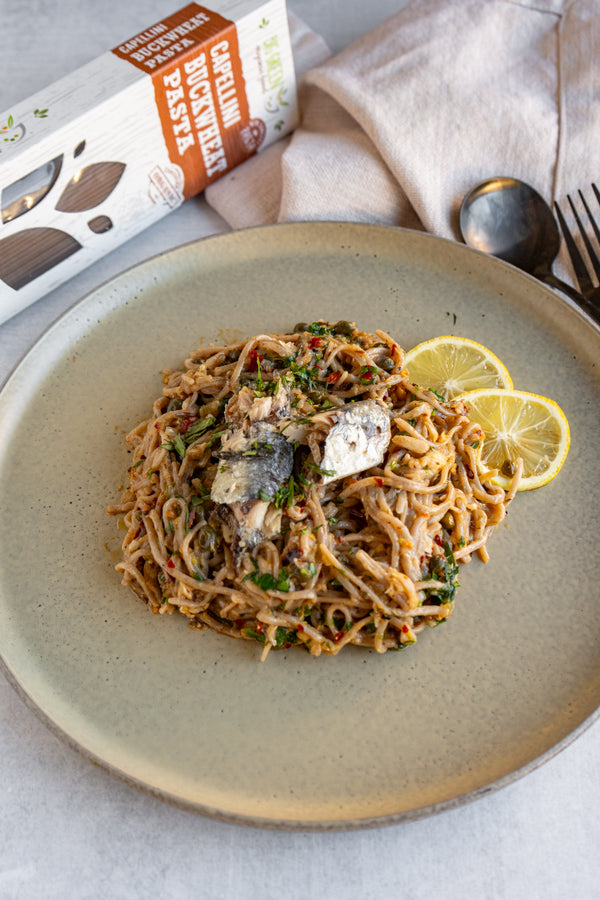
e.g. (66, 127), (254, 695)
(108, 321), (519, 658)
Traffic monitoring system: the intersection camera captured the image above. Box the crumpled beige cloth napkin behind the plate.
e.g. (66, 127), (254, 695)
(206, 0), (600, 284)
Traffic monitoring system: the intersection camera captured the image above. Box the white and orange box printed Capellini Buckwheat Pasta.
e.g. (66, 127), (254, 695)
(0, 0), (297, 322)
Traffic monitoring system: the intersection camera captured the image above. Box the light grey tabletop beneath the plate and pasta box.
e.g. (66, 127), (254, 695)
(0, 0), (600, 900)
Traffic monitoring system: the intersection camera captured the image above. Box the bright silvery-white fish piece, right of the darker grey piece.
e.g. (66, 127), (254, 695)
(319, 400), (392, 484)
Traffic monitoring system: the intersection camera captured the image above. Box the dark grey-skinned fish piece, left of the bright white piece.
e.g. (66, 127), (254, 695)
(210, 422), (294, 505)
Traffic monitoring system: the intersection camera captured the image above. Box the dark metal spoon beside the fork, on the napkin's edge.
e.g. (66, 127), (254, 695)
(459, 177), (583, 303)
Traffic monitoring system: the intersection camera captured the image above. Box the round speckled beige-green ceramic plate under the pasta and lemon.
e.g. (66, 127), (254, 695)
(0, 223), (600, 829)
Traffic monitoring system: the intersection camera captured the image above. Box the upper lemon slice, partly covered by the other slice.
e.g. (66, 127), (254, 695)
(404, 335), (513, 400)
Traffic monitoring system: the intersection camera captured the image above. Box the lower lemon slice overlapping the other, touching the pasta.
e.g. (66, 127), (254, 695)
(457, 388), (571, 491)
